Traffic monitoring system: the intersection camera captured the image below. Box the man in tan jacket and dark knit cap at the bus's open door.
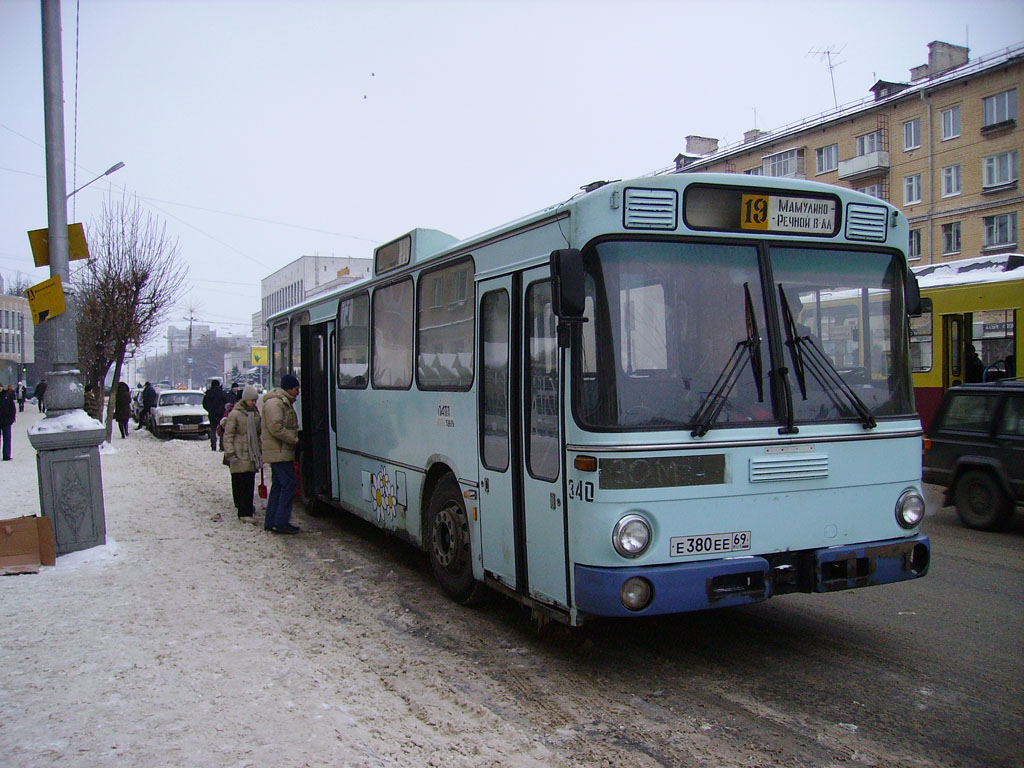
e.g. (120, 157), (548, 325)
(263, 374), (300, 534)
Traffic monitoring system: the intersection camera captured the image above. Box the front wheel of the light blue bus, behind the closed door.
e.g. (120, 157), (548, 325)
(426, 475), (486, 605)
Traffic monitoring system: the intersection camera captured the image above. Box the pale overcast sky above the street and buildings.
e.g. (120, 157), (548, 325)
(0, 0), (1024, 348)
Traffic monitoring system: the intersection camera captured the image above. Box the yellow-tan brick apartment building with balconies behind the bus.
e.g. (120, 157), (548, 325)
(675, 42), (1024, 264)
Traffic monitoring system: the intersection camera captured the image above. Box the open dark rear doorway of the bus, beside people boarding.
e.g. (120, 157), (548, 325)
(300, 321), (338, 511)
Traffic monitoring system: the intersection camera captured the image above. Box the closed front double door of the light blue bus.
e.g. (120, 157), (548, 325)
(477, 266), (568, 606)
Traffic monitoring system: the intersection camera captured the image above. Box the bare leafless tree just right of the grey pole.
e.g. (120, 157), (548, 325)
(72, 197), (188, 440)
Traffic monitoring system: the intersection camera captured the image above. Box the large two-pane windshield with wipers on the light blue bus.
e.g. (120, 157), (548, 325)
(573, 240), (913, 434)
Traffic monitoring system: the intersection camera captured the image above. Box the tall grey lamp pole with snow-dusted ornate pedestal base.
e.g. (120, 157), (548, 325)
(29, 0), (106, 555)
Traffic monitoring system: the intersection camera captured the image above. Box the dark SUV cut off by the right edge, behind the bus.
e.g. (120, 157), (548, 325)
(922, 379), (1024, 530)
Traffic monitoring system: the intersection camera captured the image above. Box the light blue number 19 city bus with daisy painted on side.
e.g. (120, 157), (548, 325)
(268, 174), (930, 626)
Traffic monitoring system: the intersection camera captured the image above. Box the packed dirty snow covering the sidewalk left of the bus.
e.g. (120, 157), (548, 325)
(0, 415), (561, 768)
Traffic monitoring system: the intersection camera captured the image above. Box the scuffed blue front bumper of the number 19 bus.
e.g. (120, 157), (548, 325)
(575, 535), (931, 616)
